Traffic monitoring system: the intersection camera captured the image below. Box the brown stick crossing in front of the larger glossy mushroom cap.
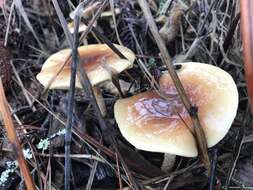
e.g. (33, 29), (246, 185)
(138, 0), (210, 173)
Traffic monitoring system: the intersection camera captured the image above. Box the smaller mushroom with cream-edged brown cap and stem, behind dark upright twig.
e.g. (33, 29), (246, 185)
(37, 44), (135, 116)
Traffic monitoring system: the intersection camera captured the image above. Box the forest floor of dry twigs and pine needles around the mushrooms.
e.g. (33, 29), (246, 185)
(0, 0), (253, 190)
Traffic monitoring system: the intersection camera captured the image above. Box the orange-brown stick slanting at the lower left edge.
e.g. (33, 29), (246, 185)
(0, 78), (35, 190)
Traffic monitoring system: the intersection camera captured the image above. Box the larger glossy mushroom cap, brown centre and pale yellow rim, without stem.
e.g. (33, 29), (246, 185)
(114, 62), (238, 157)
